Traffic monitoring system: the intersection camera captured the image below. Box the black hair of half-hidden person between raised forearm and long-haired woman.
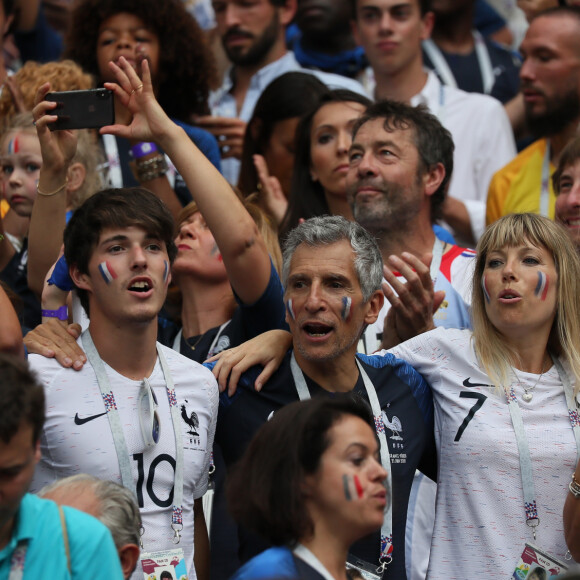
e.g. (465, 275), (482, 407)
(238, 71), (328, 195)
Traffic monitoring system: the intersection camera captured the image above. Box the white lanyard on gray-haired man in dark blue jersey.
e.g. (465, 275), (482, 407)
(290, 352), (393, 574)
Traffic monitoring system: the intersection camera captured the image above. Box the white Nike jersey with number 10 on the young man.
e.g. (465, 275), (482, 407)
(28, 339), (218, 580)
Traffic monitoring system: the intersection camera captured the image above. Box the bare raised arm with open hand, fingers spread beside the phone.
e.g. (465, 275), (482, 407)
(101, 58), (270, 304)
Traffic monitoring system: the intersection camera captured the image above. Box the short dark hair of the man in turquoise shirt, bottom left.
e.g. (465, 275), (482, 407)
(0, 353), (45, 445)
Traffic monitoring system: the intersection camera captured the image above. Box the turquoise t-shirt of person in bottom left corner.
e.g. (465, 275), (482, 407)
(0, 494), (123, 580)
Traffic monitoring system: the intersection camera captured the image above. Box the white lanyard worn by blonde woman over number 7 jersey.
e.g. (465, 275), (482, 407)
(506, 357), (580, 540)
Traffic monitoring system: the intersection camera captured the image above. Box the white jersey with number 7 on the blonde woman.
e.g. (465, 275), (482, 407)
(382, 328), (576, 580)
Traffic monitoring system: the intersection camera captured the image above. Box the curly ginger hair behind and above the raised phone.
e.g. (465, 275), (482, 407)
(0, 60), (95, 119)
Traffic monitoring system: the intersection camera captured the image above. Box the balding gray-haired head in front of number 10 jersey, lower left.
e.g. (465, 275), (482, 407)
(37, 473), (141, 579)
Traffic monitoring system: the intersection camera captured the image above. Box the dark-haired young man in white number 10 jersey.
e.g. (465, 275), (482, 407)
(30, 188), (217, 578)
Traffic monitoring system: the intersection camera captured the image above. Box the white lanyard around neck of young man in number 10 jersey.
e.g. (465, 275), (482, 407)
(81, 330), (183, 544)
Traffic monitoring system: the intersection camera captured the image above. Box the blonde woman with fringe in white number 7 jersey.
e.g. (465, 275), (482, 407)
(393, 214), (580, 579)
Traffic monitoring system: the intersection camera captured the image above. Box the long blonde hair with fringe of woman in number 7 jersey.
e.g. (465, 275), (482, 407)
(472, 213), (580, 392)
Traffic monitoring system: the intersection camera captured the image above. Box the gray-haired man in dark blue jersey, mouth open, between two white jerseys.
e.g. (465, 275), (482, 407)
(216, 216), (436, 578)
